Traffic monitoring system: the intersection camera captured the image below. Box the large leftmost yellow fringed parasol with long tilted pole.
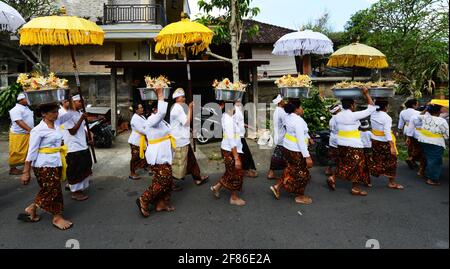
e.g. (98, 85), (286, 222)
(19, 7), (105, 162)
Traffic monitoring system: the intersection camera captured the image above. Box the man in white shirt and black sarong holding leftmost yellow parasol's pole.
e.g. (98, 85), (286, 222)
(64, 95), (92, 201)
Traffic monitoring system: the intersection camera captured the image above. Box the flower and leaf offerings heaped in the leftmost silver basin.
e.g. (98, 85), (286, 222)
(17, 73), (69, 91)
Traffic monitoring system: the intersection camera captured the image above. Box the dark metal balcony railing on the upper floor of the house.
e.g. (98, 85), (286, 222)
(103, 4), (167, 26)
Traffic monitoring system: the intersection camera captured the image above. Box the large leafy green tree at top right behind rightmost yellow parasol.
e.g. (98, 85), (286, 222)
(344, 0), (449, 97)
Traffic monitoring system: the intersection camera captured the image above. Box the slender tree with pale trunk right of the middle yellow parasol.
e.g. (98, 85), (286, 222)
(197, 0), (260, 82)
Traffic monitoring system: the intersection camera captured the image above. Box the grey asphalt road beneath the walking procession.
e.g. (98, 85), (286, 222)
(0, 135), (449, 249)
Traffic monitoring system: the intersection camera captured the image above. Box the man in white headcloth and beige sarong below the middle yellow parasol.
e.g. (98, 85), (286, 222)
(170, 88), (208, 186)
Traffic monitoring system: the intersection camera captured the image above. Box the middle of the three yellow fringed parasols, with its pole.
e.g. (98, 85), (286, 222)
(155, 14), (214, 101)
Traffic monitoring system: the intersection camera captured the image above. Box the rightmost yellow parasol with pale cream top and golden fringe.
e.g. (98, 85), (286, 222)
(327, 42), (389, 80)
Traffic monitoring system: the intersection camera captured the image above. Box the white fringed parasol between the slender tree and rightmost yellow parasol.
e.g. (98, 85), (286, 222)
(272, 30), (333, 75)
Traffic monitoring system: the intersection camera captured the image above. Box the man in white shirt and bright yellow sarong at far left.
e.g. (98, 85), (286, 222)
(9, 93), (34, 175)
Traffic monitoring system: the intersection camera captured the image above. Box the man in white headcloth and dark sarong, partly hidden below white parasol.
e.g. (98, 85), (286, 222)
(267, 95), (287, 179)
